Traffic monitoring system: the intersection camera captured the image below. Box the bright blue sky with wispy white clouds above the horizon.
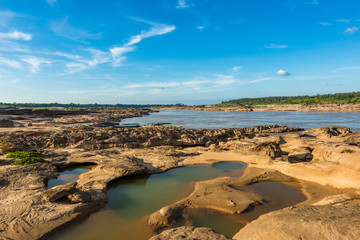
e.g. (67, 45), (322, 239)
(0, 0), (360, 104)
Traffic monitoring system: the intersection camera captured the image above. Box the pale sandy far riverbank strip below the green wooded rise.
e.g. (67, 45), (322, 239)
(158, 104), (360, 112)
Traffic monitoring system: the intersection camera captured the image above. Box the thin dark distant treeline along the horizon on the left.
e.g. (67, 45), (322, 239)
(0, 102), (184, 109)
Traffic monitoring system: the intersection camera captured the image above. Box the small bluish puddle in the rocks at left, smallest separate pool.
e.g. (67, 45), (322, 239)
(47, 165), (95, 188)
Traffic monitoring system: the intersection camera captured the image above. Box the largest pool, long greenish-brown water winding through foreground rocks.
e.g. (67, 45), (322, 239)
(51, 162), (245, 240)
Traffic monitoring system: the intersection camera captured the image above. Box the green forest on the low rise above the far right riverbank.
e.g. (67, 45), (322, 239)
(218, 92), (360, 105)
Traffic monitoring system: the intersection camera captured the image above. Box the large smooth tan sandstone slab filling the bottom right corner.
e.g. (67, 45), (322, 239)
(234, 205), (360, 240)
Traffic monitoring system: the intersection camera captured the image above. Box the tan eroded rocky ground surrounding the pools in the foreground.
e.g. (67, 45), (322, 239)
(0, 109), (360, 239)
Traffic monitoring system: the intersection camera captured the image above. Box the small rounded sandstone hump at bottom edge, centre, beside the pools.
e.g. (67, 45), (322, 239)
(149, 226), (230, 240)
